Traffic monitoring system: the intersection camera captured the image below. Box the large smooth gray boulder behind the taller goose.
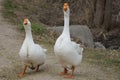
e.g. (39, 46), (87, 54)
(51, 25), (94, 48)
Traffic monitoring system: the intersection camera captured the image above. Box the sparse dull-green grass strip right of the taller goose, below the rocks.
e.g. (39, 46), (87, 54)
(84, 49), (120, 70)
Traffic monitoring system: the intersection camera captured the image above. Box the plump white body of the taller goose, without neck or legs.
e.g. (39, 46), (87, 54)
(54, 35), (83, 67)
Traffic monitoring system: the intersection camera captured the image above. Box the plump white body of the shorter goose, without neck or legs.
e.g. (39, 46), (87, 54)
(19, 37), (45, 67)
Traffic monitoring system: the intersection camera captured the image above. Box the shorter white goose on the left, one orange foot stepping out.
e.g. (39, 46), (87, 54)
(18, 19), (46, 77)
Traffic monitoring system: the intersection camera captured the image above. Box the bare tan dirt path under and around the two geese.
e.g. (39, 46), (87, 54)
(0, 0), (120, 80)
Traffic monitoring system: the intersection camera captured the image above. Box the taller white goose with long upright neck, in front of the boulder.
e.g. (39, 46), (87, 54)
(54, 3), (83, 78)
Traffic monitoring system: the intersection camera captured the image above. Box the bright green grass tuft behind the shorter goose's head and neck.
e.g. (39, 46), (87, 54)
(20, 22), (46, 34)
